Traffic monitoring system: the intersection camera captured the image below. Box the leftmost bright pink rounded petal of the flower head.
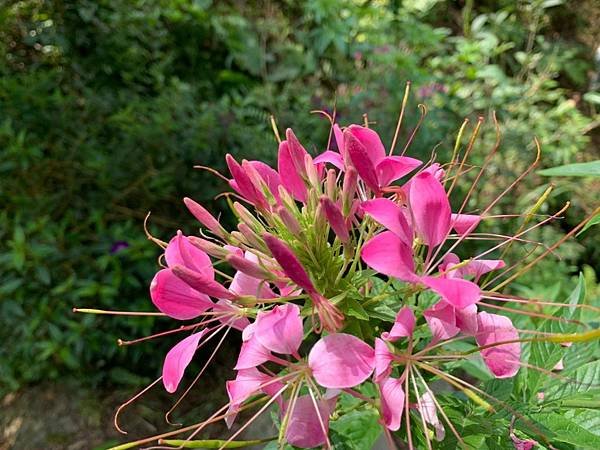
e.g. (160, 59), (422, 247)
(150, 269), (213, 320)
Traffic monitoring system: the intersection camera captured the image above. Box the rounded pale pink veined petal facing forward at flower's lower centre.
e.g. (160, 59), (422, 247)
(308, 333), (375, 389)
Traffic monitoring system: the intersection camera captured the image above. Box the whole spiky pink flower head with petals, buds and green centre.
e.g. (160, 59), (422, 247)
(145, 124), (520, 448)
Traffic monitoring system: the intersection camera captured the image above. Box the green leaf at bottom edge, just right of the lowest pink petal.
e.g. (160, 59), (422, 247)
(329, 409), (381, 450)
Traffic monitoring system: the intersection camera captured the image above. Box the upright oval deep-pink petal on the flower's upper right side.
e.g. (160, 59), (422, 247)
(409, 172), (451, 247)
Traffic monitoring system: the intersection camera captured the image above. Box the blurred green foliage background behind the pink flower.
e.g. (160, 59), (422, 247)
(0, 0), (599, 390)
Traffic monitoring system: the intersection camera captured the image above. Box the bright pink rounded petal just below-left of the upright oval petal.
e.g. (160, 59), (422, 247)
(361, 231), (418, 282)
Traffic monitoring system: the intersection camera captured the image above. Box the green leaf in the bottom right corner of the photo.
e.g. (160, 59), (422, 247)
(530, 413), (600, 450)
